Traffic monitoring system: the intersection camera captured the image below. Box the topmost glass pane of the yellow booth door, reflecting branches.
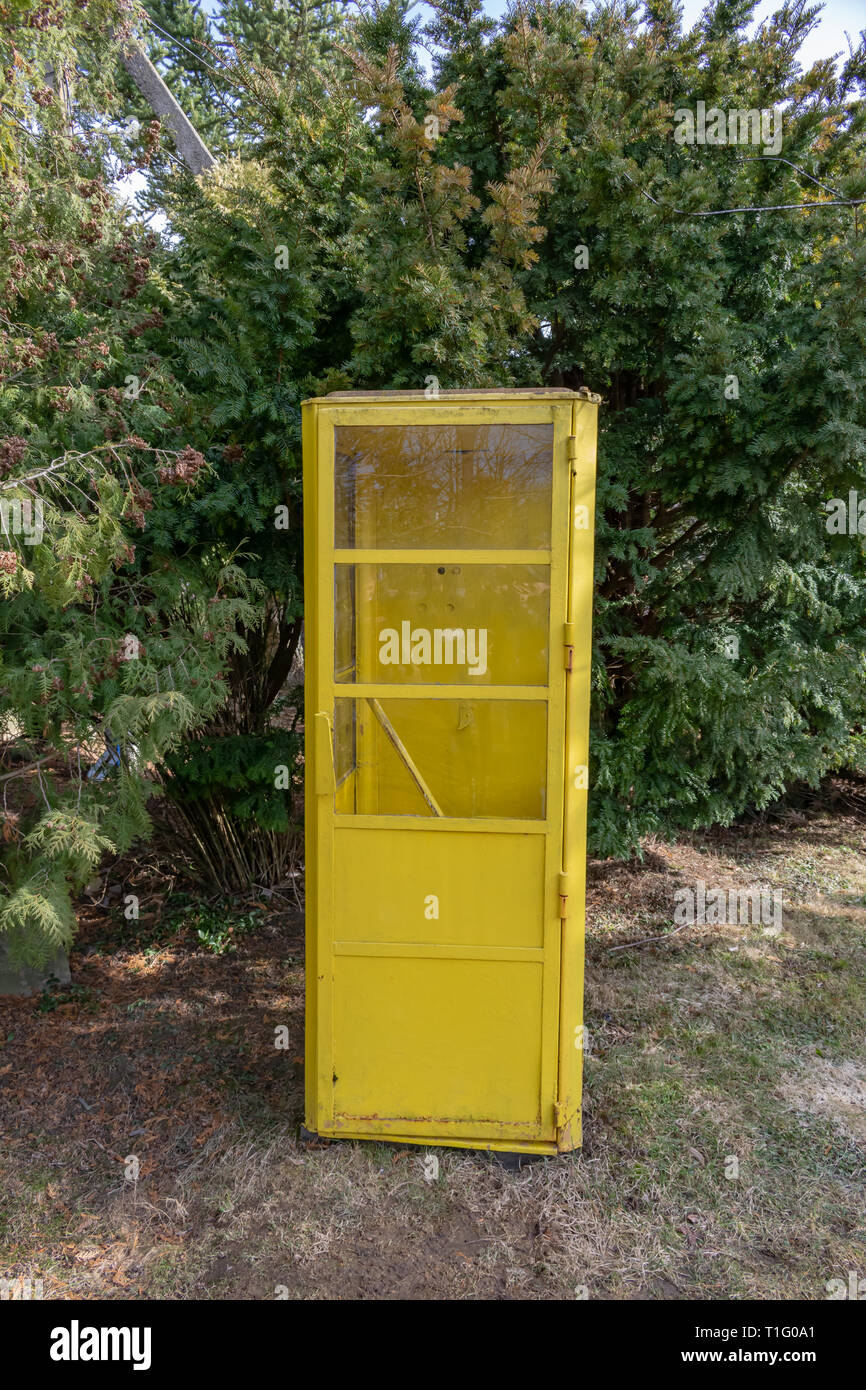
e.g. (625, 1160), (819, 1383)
(334, 424), (553, 550)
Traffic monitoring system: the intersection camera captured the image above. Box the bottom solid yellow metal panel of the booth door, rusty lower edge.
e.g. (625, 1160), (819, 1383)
(332, 955), (550, 1138)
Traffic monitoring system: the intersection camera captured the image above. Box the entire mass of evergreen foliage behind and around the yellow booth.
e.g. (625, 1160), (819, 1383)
(0, 0), (866, 978)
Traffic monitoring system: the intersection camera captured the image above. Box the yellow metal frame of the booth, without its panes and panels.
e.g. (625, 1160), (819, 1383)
(302, 391), (596, 1154)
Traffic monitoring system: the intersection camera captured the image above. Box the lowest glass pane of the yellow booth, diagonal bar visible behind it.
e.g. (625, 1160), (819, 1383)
(334, 696), (548, 820)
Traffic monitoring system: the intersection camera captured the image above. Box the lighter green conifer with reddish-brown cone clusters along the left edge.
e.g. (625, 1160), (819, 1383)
(0, 4), (261, 966)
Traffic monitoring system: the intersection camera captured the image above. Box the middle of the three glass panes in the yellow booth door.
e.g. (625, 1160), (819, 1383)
(334, 563), (550, 685)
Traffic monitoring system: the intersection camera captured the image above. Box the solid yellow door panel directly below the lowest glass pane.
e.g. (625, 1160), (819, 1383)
(334, 828), (545, 947)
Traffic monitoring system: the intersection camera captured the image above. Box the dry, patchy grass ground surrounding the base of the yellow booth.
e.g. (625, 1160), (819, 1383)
(0, 817), (866, 1298)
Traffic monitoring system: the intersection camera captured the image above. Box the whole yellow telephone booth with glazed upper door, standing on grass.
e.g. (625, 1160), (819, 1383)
(303, 389), (598, 1154)
